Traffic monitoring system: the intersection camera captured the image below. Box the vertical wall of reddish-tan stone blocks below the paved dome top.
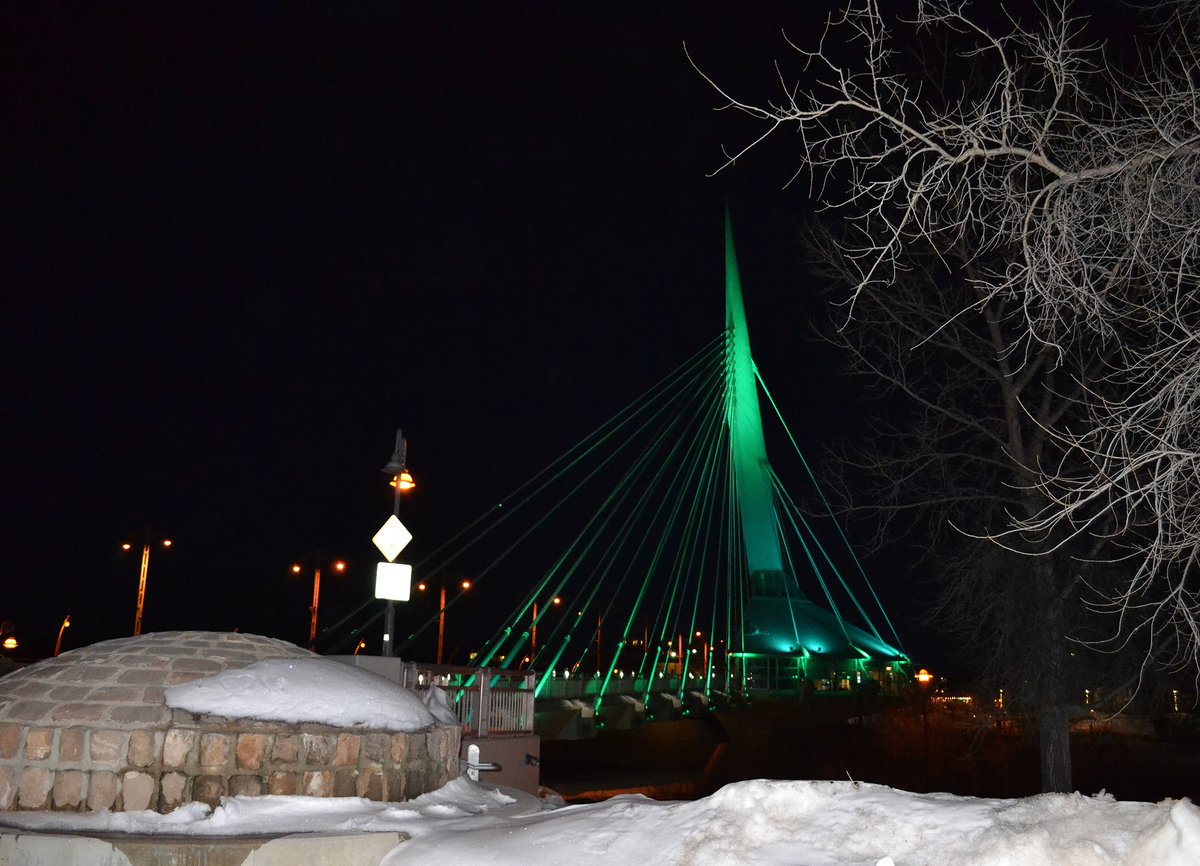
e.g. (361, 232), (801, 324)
(0, 710), (461, 812)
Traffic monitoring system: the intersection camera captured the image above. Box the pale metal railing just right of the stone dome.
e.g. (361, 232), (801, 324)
(400, 662), (536, 736)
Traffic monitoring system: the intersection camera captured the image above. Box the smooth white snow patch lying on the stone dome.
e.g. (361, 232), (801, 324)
(163, 656), (444, 730)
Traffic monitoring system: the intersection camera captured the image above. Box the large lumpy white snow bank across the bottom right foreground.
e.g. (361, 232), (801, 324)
(383, 781), (1200, 866)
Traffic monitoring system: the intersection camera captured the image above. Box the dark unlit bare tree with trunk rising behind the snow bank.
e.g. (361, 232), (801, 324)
(816, 227), (1109, 790)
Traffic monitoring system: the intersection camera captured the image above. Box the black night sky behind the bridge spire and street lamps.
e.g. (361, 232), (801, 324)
(0, 0), (923, 656)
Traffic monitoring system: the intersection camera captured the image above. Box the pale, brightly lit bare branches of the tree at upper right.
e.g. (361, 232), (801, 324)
(710, 0), (1200, 788)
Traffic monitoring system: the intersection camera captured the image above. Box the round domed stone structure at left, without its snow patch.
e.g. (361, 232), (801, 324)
(0, 631), (461, 811)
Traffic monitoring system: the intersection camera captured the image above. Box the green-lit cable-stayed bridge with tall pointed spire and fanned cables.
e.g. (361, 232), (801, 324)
(333, 217), (908, 712)
